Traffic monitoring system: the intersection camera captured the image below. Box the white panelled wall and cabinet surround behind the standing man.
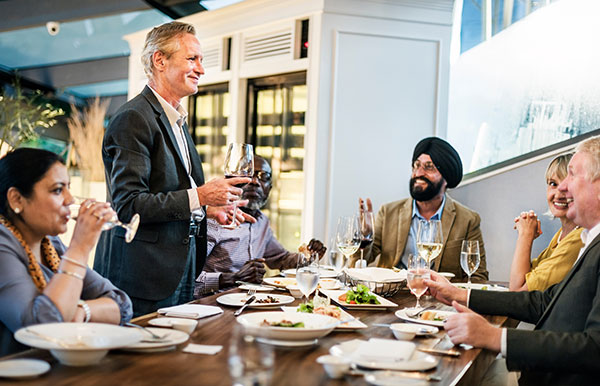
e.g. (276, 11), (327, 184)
(125, 0), (453, 250)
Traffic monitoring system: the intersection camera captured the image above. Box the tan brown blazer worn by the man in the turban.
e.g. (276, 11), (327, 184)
(351, 194), (488, 282)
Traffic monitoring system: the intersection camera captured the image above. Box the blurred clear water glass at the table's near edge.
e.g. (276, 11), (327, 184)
(229, 323), (275, 386)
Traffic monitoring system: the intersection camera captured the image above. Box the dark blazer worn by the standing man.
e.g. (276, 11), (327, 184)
(94, 86), (206, 301)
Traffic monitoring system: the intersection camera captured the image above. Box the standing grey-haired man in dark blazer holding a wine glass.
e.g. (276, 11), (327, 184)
(94, 22), (250, 316)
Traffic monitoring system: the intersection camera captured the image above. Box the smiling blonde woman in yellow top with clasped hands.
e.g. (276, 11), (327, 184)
(509, 154), (583, 291)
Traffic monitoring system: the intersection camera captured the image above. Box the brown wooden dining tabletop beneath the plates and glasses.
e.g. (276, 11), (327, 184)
(0, 282), (516, 386)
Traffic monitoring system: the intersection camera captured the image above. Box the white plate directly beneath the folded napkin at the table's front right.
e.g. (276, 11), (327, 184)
(329, 339), (439, 371)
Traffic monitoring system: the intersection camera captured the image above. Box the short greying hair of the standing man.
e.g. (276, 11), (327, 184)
(142, 21), (196, 78)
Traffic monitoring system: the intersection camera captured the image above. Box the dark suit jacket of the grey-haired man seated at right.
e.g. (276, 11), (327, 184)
(469, 231), (600, 385)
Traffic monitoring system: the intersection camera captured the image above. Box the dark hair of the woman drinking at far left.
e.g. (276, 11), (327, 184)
(0, 147), (64, 216)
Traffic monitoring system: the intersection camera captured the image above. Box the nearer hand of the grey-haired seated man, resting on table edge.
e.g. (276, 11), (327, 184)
(444, 301), (502, 352)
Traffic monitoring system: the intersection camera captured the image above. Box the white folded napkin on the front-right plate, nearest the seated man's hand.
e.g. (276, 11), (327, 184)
(354, 338), (416, 362)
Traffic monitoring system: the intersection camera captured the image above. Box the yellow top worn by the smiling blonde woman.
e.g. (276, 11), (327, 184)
(525, 228), (583, 291)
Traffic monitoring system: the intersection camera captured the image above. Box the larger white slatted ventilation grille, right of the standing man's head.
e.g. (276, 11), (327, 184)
(244, 29), (292, 62)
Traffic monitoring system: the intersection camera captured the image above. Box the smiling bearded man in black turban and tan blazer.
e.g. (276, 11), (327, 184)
(353, 137), (488, 282)
